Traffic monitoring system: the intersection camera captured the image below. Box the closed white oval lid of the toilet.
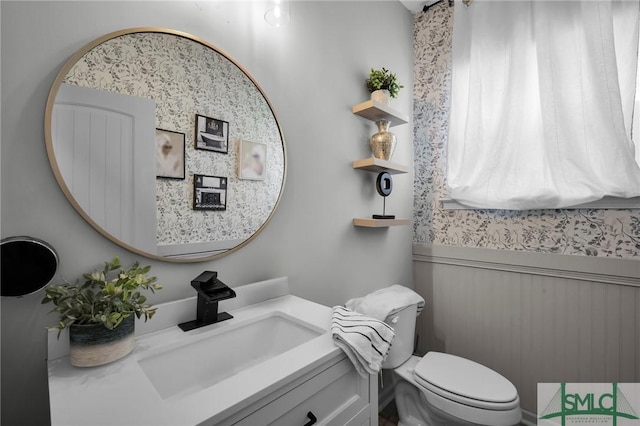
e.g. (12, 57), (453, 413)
(413, 352), (519, 409)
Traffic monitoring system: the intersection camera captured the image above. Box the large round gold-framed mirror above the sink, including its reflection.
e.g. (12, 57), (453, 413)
(45, 28), (286, 262)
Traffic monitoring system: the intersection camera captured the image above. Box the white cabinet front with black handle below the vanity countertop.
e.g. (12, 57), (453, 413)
(221, 354), (377, 426)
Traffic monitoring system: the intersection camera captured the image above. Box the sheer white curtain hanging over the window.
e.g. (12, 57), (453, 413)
(447, 0), (640, 210)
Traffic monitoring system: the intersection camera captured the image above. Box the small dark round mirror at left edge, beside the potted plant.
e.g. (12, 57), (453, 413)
(0, 237), (58, 297)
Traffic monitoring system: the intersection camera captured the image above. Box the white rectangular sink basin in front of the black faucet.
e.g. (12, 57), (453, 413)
(138, 311), (326, 399)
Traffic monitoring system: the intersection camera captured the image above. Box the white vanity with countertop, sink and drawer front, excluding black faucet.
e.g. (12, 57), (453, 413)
(47, 277), (378, 426)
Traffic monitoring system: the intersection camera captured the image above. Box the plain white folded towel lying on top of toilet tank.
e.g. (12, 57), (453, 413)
(345, 284), (424, 321)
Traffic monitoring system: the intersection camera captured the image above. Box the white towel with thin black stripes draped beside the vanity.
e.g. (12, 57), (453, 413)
(331, 306), (395, 377)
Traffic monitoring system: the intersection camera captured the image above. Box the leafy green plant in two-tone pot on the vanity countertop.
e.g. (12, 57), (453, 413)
(42, 256), (162, 367)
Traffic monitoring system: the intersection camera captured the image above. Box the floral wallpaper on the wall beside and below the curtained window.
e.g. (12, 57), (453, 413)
(413, 2), (640, 259)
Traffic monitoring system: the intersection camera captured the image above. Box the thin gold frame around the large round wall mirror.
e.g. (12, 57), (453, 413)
(44, 27), (287, 263)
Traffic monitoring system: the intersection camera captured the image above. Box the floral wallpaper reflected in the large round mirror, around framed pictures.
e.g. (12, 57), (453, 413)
(64, 33), (285, 250)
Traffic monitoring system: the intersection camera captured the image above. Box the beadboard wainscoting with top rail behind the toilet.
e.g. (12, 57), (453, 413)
(413, 243), (640, 413)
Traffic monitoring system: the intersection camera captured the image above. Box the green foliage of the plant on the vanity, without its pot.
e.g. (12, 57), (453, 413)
(42, 256), (162, 337)
